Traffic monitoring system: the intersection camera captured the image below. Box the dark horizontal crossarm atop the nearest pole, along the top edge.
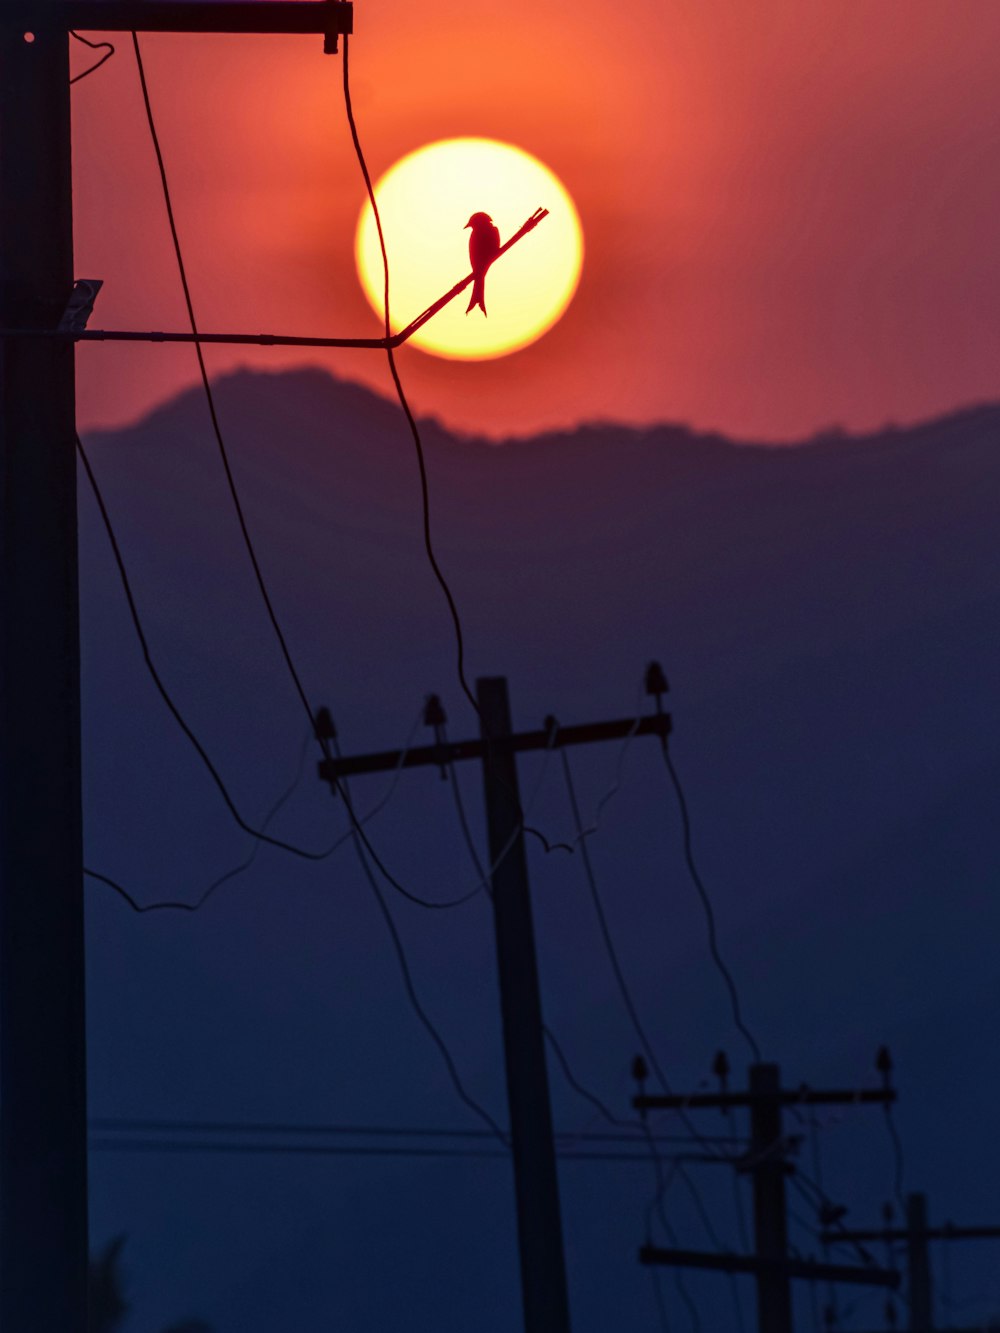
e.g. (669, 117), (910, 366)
(0, 0), (353, 36)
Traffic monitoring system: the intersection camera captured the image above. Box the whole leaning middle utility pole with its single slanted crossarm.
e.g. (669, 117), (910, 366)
(320, 676), (671, 1333)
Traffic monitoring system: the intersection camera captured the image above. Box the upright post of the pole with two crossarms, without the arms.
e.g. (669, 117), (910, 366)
(749, 1065), (792, 1333)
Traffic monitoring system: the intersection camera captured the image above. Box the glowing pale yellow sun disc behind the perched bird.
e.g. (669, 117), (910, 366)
(355, 139), (584, 361)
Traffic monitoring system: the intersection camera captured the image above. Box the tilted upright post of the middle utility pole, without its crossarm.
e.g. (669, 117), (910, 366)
(476, 676), (569, 1333)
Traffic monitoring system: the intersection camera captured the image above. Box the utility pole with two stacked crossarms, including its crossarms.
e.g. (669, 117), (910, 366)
(632, 1064), (899, 1333)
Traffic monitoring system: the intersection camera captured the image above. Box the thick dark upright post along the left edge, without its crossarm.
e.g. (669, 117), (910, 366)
(0, 12), (87, 1333)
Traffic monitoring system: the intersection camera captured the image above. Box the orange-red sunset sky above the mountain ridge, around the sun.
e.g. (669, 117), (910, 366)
(73, 0), (1000, 439)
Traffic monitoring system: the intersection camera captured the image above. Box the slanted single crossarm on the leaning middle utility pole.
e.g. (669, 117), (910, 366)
(319, 713), (671, 782)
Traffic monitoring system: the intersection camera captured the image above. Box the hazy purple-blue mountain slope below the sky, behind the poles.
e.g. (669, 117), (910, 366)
(81, 369), (1000, 1333)
